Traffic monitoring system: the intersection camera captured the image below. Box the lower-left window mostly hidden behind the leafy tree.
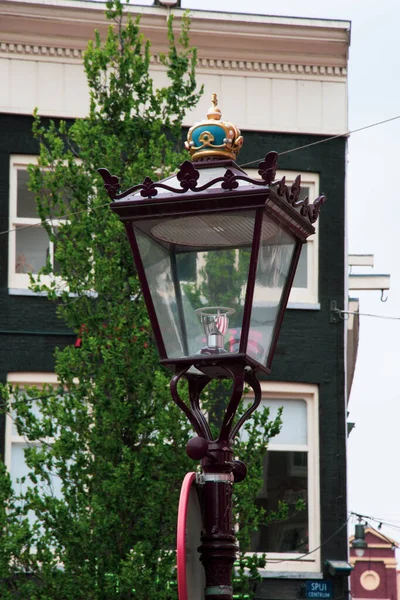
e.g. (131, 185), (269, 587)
(4, 373), (61, 523)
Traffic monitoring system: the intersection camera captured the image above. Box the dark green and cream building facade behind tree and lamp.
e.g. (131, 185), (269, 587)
(0, 0), (354, 600)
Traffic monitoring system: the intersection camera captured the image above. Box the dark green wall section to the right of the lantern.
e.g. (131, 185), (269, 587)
(238, 132), (347, 598)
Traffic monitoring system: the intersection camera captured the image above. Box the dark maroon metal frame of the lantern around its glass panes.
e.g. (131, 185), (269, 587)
(99, 152), (326, 378)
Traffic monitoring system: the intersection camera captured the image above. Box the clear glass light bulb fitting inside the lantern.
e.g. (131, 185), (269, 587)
(195, 306), (236, 354)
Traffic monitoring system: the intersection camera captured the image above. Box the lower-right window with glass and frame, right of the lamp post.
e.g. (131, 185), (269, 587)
(244, 381), (320, 572)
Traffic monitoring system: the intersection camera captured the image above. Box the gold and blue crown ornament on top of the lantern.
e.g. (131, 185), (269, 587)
(185, 94), (243, 161)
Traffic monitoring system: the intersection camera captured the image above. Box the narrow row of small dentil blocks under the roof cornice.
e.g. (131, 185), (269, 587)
(0, 42), (347, 78)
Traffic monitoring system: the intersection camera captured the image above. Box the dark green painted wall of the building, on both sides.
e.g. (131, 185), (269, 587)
(0, 114), (347, 597)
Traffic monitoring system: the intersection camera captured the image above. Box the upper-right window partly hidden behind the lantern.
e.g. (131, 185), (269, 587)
(247, 169), (320, 308)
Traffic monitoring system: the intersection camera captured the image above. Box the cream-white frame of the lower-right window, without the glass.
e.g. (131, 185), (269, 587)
(242, 381), (321, 577)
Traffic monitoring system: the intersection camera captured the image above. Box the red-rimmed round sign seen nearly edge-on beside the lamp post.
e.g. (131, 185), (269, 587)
(176, 473), (205, 600)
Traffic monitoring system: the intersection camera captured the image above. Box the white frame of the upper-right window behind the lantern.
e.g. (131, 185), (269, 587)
(246, 169), (320, 309)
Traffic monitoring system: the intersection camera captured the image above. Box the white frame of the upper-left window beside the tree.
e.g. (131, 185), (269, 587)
(8, 154), (63, 294)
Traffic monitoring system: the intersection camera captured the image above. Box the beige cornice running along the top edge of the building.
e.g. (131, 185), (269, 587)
(0, 0), (350, 69)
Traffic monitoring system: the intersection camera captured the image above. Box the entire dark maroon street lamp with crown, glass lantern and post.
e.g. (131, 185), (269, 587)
(99, 94), (325, 600)
